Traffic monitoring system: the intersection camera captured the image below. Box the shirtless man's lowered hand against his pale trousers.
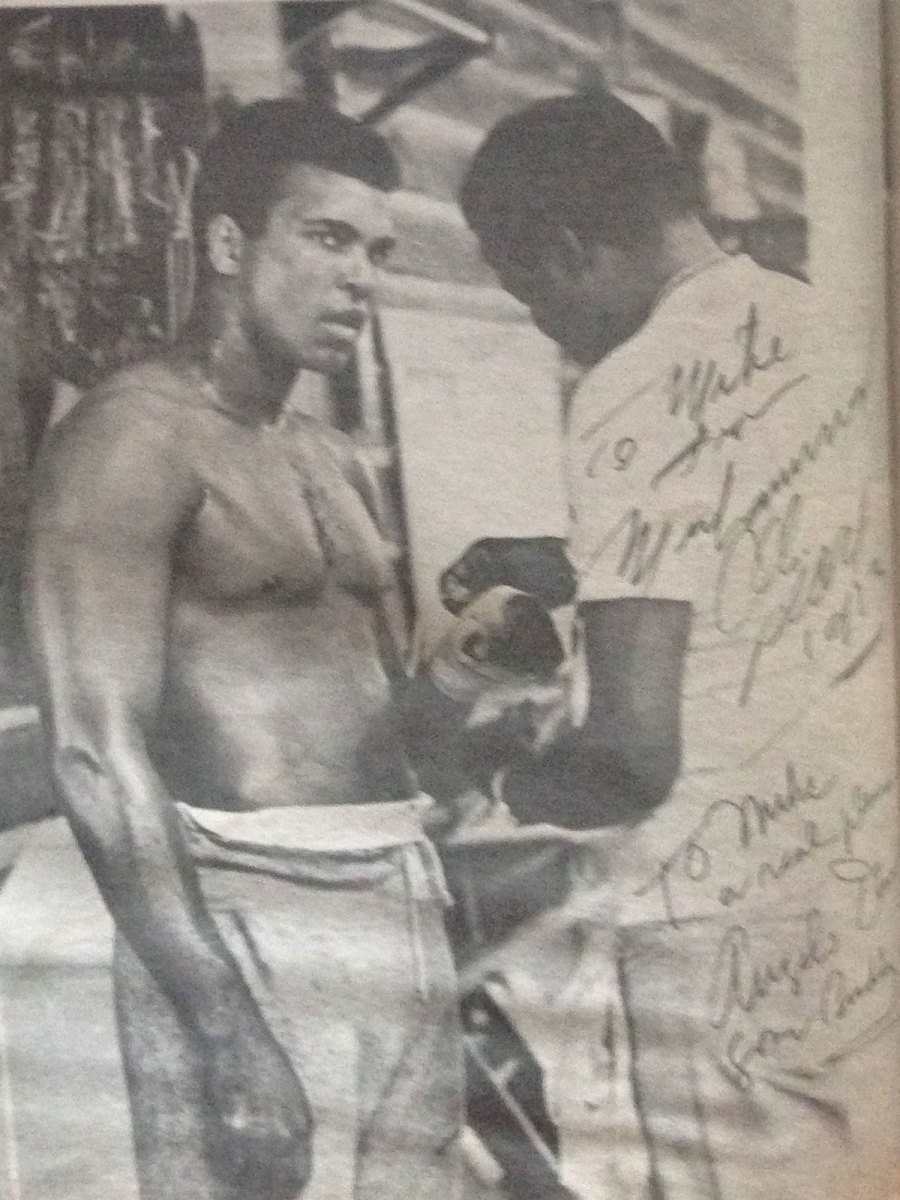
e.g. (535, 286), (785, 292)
(203, 1008), (312, 1200)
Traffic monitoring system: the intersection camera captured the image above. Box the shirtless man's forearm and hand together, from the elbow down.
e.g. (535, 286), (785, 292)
(56, 751), (312, 1200)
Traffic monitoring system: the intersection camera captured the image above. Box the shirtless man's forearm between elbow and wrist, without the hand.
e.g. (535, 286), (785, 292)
(54, 749), (253, 1040)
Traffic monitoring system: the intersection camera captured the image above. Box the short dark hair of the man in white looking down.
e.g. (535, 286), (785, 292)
(460, 90), (700, 251)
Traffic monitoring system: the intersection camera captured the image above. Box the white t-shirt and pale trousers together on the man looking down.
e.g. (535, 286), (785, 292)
(480, 256), (900, 1200)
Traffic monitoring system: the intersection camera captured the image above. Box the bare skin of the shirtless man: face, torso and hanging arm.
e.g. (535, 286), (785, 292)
(28, 166), (403, 1200)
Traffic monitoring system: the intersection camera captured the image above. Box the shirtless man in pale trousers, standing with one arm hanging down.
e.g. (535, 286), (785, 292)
(28, 101), (461, 1200)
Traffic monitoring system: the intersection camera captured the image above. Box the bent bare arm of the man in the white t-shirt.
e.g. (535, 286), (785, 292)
(504, 598), (691, 829)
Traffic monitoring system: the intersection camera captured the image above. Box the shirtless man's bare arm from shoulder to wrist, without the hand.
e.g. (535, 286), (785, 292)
(25, 393), (243, 1028)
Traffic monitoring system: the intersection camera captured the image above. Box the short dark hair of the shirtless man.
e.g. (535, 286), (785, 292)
(193, 100), (400, 236)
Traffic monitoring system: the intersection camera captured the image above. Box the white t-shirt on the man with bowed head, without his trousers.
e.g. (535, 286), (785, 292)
(568, 256), (893, 919)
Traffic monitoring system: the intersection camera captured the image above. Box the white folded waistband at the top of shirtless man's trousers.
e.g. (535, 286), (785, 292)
(178, 796), (434, 853)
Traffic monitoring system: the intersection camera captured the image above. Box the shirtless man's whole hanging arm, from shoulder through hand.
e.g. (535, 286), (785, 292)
(26, 396), (308, 1200)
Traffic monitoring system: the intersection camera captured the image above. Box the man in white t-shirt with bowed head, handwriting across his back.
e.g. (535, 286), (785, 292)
(462, 94), (900, 1200)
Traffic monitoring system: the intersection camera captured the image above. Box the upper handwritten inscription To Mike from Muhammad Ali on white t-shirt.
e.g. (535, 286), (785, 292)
(581, 297), (884, 707)
